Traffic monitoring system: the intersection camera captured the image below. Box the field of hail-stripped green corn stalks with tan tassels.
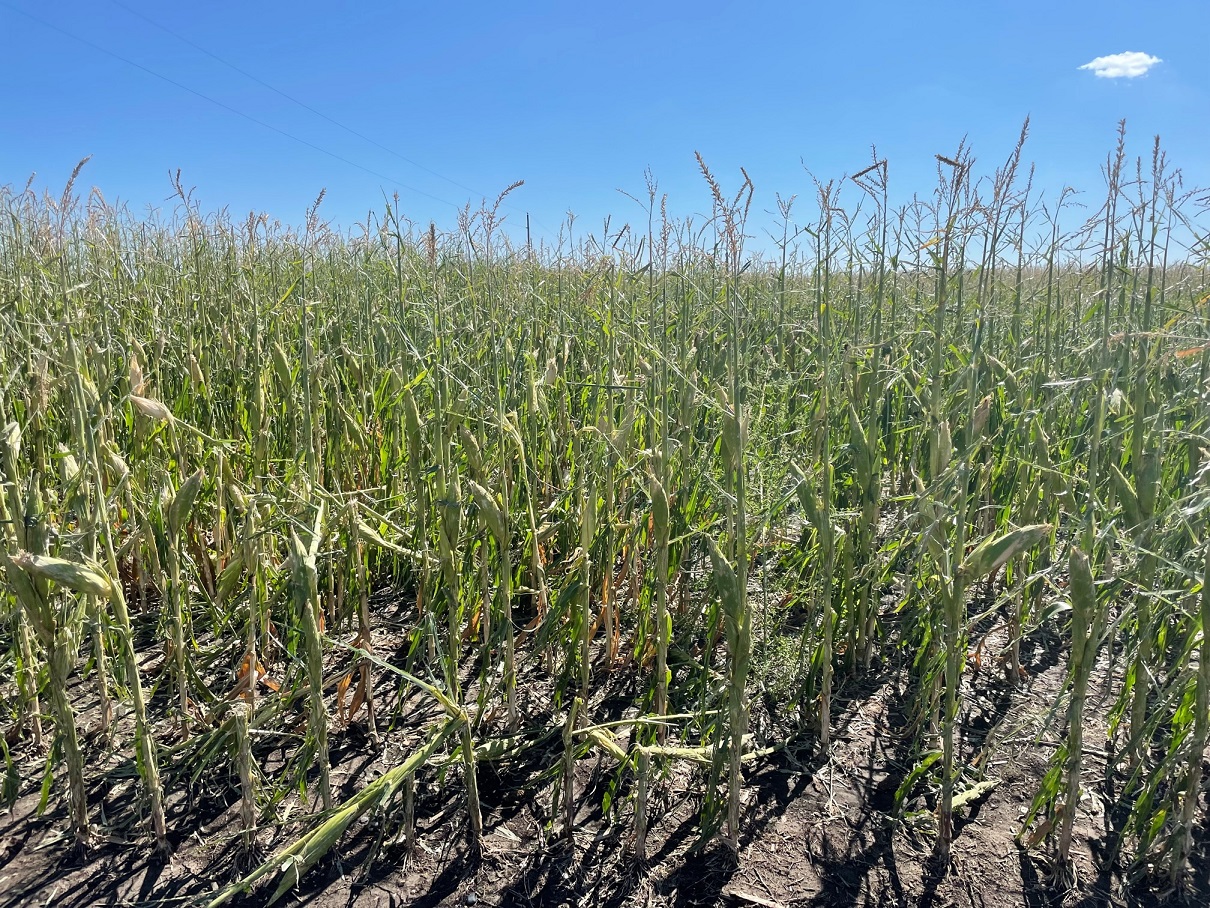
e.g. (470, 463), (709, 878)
(0, 130), (1210, 906)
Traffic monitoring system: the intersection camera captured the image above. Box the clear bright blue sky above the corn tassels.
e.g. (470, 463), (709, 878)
(0, 0), (1210, 245)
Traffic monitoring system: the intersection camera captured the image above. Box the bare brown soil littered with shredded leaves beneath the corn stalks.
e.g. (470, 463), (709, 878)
(0, 585), (1210, 908)
